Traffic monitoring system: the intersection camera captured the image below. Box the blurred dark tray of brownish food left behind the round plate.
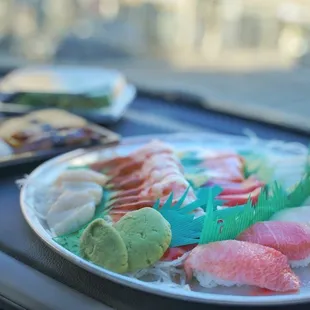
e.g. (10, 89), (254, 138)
(0, 109), (120, 168)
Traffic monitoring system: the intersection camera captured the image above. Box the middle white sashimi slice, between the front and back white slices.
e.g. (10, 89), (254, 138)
(61, 182), (103, 204)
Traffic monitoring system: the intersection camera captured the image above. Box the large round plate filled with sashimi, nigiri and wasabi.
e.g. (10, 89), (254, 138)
(18, 133), (310, 305)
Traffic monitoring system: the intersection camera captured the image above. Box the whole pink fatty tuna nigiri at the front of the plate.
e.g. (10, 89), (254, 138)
(184, 240), (300, 292)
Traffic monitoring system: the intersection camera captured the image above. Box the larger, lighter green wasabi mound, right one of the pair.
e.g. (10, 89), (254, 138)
(114, 208), (171, 272)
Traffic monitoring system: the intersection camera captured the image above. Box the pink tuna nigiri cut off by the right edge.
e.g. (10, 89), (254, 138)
(237, 221), (310, 267)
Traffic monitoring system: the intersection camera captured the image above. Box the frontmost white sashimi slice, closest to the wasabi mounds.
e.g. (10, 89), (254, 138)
(46, 191), (96, 236)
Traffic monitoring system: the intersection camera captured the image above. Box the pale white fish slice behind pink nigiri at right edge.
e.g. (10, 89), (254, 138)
(270, 206), (310, 226)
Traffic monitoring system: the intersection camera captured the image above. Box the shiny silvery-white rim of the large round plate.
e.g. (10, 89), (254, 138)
(20, 132), (310, 306)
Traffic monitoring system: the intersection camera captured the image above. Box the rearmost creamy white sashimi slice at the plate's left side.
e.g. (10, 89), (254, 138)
(55, 169), (108, 186)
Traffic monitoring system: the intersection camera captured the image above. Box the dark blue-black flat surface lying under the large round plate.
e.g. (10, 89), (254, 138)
(0, 88), (309, 309)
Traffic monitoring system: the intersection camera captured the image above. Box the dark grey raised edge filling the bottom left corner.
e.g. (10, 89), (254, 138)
(0, 252), (111, 310)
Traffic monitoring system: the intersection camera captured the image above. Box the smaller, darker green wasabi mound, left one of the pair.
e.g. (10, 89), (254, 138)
(80, 219), (128, 273)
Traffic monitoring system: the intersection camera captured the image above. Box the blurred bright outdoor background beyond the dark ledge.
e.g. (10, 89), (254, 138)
(0, 0), (310, 116)
